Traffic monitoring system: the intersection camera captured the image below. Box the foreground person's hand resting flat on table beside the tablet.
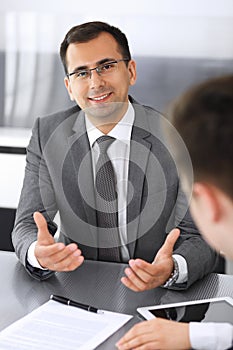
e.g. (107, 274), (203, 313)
(116, 318), (191, 350)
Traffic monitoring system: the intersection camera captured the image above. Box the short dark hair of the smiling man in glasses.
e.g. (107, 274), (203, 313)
(60, 21), (131, 73)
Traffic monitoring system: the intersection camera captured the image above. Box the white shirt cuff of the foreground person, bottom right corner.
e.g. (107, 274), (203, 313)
(189, 322), (233, 350)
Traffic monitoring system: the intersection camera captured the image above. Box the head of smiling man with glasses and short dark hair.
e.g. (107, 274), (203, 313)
(60, 21), (136, 133)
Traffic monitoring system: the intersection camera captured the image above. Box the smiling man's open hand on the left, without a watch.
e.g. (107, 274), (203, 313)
(33, 212), (84, 271)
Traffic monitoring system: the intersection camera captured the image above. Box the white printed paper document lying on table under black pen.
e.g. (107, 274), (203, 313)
(0, 300), (133, 350)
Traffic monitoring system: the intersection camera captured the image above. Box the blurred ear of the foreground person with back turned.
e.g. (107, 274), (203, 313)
(193, 182), (221, 222)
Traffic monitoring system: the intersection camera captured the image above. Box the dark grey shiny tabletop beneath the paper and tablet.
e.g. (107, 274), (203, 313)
(0, 251), (233, 350)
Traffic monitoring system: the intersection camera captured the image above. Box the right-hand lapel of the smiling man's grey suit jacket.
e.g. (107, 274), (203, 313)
(127, 104), (151, 257)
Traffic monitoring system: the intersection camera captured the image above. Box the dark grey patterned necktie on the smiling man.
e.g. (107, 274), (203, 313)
(95, 135), (121, 262)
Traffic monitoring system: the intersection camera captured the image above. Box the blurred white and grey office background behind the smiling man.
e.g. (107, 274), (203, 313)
(0, 0), (233, 271)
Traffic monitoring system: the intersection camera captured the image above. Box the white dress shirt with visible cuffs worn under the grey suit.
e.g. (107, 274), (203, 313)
(28, 102), (188, 283)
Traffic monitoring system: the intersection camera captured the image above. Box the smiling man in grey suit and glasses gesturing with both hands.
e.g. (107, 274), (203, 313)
(12, 22), (218, 291)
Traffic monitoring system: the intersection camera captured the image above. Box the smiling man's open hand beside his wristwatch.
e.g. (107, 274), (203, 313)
(121, 229), (180, 292)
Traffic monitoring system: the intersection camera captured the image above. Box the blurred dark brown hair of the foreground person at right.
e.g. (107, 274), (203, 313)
(168, 75), (233, 199)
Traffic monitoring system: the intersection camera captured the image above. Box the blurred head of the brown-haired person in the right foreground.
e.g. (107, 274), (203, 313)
(168, 75), (233, 258)
